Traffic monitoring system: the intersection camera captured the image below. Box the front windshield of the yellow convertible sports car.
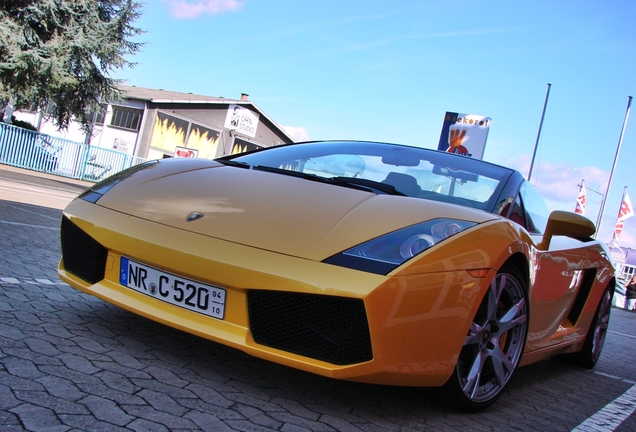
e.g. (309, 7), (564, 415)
(219, 141), (512, 211)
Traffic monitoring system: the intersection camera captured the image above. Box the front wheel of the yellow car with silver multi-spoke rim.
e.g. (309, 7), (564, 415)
(441, 266), (528, 412)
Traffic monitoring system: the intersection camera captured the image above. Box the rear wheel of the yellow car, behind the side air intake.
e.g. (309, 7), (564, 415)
(555, 287), (614, 369)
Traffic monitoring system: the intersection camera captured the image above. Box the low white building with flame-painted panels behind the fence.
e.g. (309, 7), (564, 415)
(14, 86), (293, 159)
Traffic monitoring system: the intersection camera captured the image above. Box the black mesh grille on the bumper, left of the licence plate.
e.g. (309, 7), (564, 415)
(60, 217), (108, 284)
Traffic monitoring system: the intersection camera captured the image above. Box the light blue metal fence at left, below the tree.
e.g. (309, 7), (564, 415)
(0, 122), (145, 182)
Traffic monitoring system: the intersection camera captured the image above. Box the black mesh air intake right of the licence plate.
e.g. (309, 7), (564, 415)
(248, 290), (373, 365)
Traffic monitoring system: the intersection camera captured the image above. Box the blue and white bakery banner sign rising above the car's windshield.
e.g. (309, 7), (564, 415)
(437, 111), (492, 159)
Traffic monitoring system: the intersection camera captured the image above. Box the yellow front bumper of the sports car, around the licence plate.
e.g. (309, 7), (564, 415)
(59, 200), (490, 386)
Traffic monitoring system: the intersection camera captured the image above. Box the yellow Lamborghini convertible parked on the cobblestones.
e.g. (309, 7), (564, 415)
(59, 141), (615, 410)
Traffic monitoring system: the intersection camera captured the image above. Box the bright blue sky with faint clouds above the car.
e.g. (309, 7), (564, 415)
(115, 0), (636, 248)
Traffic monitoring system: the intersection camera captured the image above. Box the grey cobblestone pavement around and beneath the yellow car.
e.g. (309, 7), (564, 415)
(0, 166), (636, 432)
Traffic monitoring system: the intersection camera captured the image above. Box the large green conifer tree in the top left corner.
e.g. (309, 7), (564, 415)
(0, 0), (143, 130)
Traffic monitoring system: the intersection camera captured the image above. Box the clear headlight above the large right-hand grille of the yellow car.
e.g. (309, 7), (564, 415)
(324, 219), (476, 274)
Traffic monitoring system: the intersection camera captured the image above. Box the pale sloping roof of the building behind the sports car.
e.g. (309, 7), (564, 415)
(119, 85), (294, 142)
